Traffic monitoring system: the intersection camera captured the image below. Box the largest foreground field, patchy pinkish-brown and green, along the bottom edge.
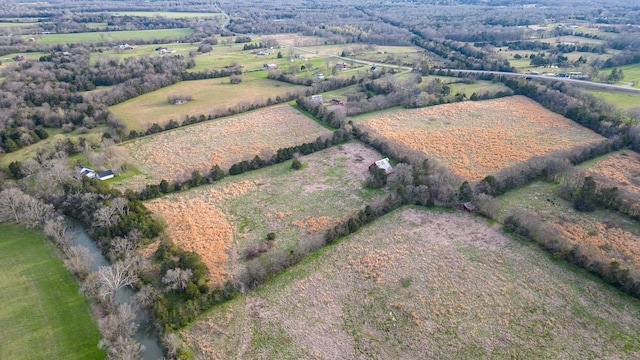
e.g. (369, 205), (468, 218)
(180, 207), (640, 359)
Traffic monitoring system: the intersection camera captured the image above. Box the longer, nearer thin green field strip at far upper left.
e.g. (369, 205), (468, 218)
(24, 29), (193, 44)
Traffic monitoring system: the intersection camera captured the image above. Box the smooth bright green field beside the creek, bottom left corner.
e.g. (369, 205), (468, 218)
(0, 224), (105, 360)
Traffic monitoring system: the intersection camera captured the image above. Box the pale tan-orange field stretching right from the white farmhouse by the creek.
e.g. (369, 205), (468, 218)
(115, 105), (331, 189)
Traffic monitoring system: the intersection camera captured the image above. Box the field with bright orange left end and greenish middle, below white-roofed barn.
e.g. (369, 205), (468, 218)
(146, 142), (385, 284)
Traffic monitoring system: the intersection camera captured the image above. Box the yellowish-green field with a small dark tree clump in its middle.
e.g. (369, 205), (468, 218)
(110, 75), (302, 130)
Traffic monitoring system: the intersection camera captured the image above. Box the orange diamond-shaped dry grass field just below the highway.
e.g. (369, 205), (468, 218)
(354, 96), (603, 180)
